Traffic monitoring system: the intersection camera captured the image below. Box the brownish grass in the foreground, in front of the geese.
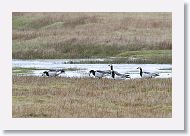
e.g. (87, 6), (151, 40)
(12, 76), (172, 118)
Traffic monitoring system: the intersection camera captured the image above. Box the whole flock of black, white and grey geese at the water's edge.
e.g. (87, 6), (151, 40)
(42, 65), (159, 79)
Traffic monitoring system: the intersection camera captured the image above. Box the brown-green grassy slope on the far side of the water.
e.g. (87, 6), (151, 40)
(12, 13), (172, 63)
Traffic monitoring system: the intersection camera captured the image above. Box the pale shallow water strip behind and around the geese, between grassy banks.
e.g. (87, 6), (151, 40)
(12, 59), (172, 78)
